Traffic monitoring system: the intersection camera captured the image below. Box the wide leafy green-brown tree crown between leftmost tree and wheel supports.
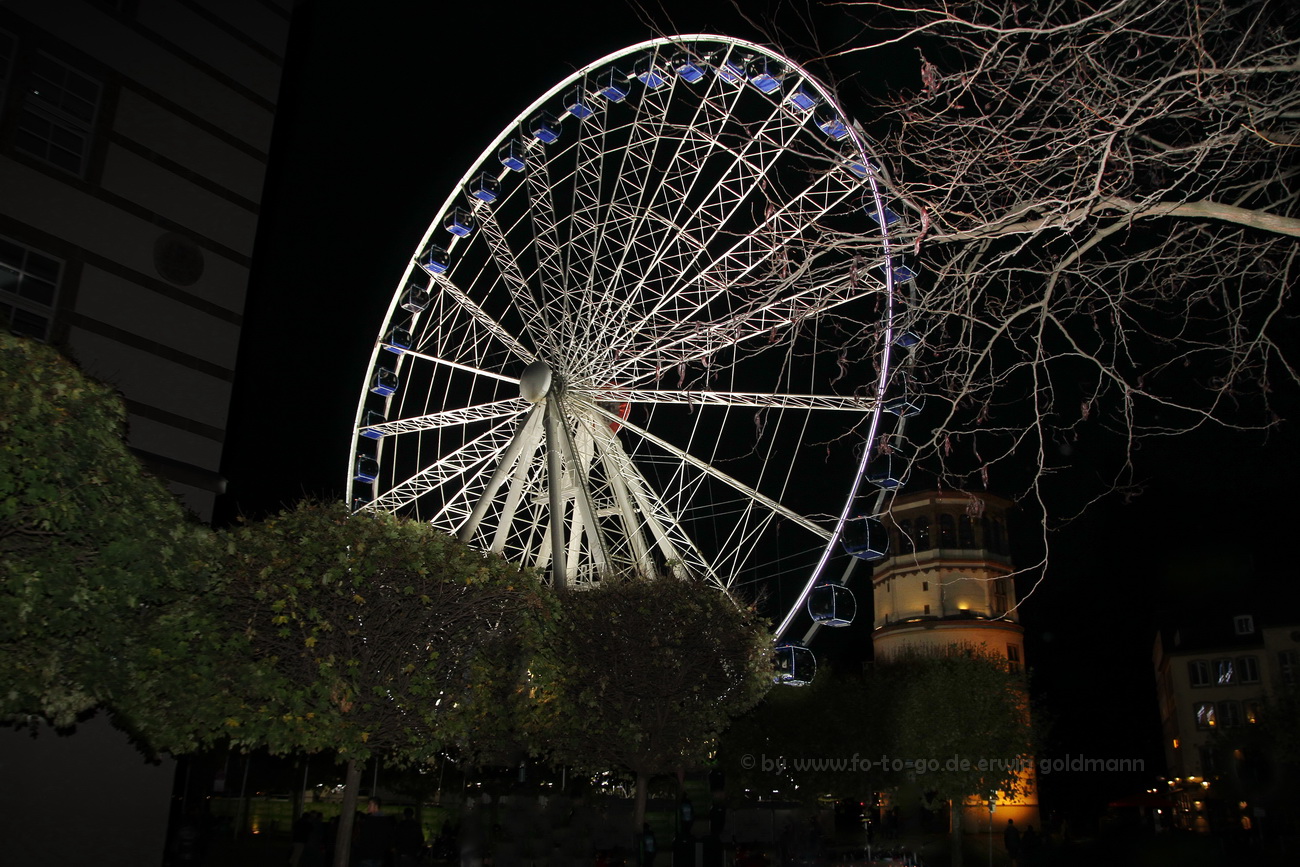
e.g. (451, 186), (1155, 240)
(176, 503), (541, 764)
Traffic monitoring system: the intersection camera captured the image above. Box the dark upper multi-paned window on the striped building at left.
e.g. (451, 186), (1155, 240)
(14, 53), (100, 174)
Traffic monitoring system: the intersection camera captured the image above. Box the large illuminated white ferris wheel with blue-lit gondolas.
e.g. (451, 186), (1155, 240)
(348, 35), (914, 670)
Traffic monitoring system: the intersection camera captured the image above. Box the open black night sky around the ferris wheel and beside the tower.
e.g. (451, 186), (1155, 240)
(218, 0), (1296, 816)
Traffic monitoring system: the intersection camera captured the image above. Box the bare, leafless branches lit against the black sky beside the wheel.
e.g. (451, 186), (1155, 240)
(823, 0), (1300, 522)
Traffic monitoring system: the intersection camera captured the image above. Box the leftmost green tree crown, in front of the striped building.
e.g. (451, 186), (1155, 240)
(0, 331), (208, 725)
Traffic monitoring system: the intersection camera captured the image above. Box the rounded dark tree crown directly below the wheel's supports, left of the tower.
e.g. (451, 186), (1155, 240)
(533, 577), (772, 829)
